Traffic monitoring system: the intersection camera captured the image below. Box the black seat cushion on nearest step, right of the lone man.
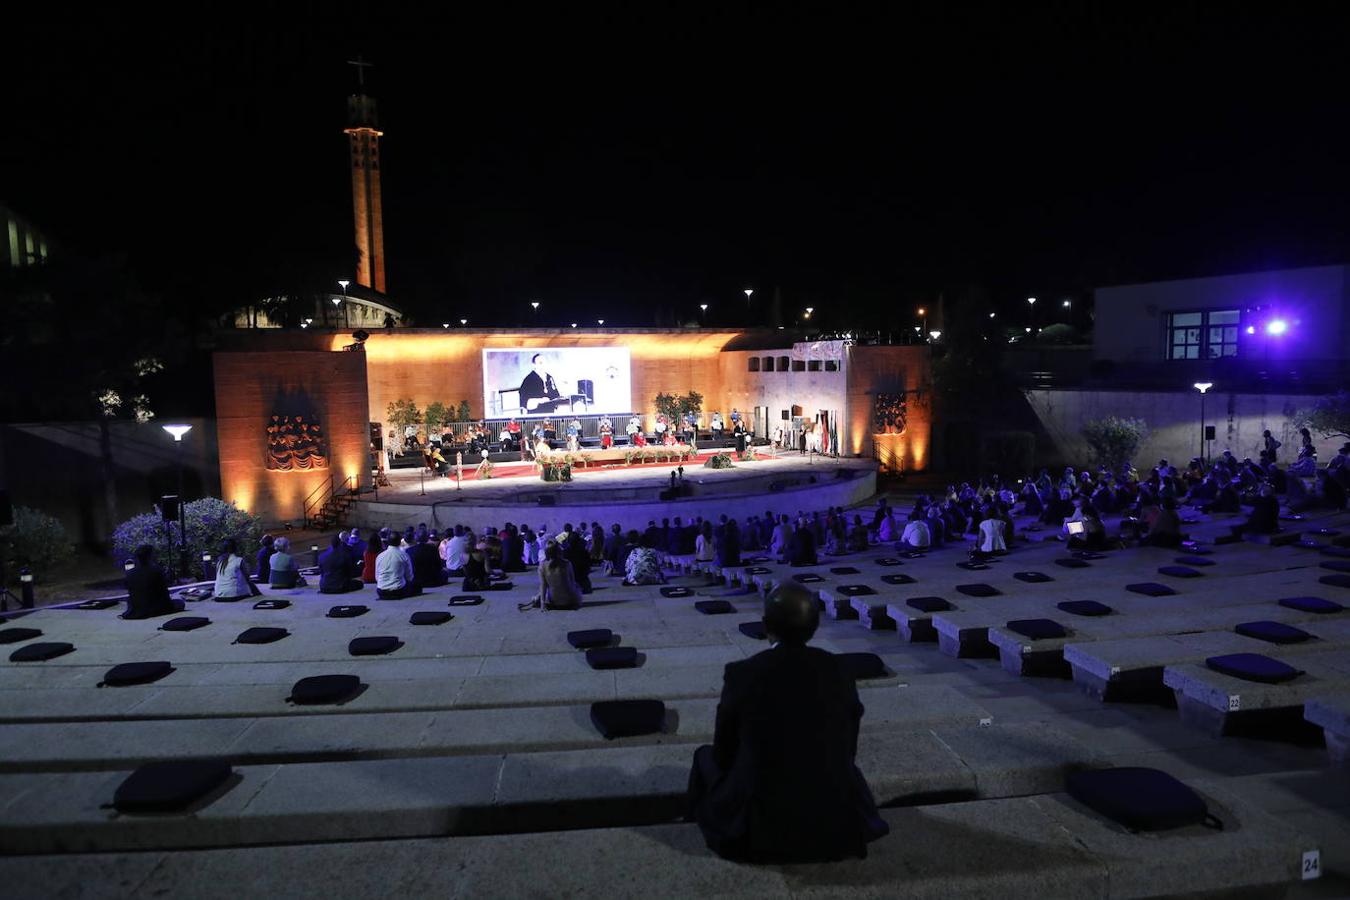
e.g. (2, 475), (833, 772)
(1065, 766), (1216, 831)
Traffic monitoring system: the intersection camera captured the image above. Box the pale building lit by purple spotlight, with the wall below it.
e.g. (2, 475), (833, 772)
(1025, 266), (1350, 461)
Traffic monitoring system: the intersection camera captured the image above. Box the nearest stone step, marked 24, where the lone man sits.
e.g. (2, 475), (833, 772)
(0, 781), (1318, 900)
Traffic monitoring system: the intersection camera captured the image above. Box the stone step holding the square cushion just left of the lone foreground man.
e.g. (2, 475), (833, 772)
(0, 685), (994, 772)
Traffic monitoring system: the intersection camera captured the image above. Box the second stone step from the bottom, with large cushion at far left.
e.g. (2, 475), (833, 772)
(0, 723), (1095, 853)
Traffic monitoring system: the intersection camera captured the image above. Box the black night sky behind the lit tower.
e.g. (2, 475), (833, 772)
(0, 3), (1350, 325)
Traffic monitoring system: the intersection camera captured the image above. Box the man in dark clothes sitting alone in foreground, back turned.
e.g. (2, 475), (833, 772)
(689, 584), (890, 862)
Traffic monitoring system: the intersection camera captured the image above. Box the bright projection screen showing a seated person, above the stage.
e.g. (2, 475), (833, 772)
(483, 347), (633, 418)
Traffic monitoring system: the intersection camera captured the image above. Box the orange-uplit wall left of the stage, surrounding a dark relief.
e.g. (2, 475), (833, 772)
(215, 351), (370, 524)
